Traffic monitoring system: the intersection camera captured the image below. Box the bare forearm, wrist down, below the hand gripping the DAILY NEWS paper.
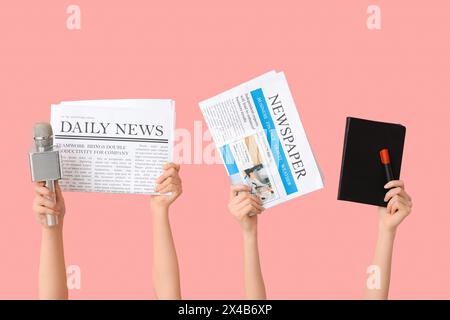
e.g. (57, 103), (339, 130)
(153, 209), (181, 299)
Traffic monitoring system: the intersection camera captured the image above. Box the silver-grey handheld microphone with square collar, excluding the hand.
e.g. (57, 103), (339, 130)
(29, 122), (61, 227)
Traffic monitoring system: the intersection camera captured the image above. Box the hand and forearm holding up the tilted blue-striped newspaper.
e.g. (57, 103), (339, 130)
(228, 185), (267, 300)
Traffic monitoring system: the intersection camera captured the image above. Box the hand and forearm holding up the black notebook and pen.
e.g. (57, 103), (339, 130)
(365, 180), (412, 300)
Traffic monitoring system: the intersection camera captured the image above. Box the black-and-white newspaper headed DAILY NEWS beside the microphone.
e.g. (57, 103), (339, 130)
(51, 99), (175, 194)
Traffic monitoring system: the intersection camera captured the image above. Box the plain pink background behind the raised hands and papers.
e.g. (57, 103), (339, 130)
(0, 0), (450, 299)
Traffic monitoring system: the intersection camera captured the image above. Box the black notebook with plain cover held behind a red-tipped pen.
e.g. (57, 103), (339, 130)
(338, 117), (406, 207)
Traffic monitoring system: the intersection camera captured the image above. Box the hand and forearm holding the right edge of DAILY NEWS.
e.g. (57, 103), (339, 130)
(150, 163), (182, 300)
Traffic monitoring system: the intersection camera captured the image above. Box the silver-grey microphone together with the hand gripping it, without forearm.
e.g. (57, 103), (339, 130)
(29, 122), (64, 227)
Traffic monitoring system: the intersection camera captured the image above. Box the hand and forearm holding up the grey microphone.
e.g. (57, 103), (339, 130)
(33, 182), (68, 300)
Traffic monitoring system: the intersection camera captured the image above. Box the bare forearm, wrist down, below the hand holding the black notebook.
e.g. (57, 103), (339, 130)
(365, 230), (395, 300)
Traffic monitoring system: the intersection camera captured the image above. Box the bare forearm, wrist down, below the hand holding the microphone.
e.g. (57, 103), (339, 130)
(39, 221), (68, 300)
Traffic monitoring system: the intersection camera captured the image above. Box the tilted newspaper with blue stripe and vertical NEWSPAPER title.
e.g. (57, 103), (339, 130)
(199, 71), (323, 208)
